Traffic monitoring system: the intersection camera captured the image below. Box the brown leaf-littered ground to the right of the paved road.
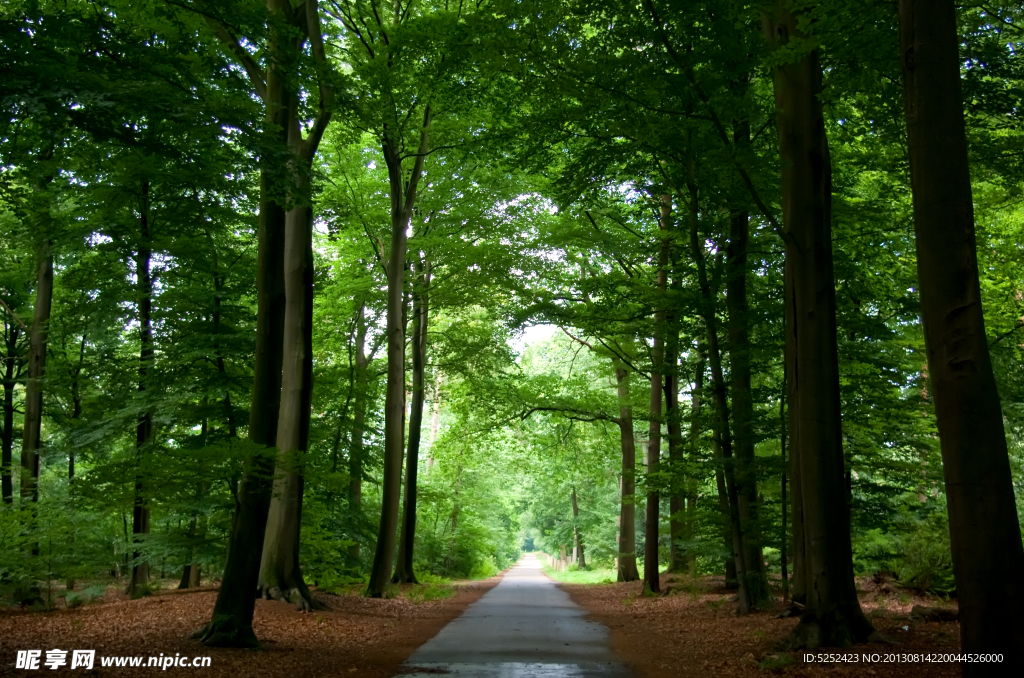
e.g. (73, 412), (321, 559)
(561, 575), (962, 678)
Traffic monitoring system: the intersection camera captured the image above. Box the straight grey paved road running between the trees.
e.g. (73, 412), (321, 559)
(397, 553), (633, 678)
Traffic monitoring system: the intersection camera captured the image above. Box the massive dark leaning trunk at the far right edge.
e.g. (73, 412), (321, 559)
(899, 0), (1024, 676)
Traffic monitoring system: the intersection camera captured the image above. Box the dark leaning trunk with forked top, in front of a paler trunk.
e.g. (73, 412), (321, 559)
(194, 0), (334, 646)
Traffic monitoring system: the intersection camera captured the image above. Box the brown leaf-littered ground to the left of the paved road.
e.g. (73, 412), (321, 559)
(0, 576), (501, 678)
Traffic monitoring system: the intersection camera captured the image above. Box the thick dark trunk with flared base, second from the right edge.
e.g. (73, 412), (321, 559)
(766, 0), (873, 648)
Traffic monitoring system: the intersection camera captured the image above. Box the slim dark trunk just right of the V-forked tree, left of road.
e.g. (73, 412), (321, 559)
(391, 259), (430, 584)
